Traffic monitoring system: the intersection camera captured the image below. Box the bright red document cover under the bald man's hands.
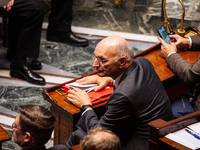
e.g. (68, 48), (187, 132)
(61, 86), (113, 105)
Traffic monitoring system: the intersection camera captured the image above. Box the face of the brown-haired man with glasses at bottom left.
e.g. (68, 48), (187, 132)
(12, 114), (25, 146)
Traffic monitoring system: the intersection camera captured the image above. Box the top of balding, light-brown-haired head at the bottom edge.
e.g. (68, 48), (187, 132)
(81, 127), (121, 150)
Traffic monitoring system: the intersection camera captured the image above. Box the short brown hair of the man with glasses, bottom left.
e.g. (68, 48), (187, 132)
(19, 105), (55, 145)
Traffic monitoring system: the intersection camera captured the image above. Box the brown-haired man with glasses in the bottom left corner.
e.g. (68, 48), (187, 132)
(12, 105), (67, 150)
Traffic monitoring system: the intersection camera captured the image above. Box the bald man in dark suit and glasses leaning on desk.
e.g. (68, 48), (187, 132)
(66, 36), (172, 150)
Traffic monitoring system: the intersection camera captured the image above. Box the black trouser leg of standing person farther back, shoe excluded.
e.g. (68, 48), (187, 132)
(47, 0), (73, 33)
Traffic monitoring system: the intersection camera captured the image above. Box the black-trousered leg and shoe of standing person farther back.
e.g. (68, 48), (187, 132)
(47, 0), (89, 47)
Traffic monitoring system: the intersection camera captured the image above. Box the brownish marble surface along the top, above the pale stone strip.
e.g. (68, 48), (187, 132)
(43, 0), (200, 35)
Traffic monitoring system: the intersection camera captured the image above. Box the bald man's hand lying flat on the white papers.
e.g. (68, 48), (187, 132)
(76, 75), (113, 91)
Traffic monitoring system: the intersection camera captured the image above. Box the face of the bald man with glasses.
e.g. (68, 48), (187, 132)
(93, 43), (120, 79)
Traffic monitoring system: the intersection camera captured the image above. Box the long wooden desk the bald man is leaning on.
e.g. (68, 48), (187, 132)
(42, 44), (200, 145)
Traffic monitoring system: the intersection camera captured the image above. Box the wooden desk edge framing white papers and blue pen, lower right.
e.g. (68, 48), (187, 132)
(148, 110), (200, 150)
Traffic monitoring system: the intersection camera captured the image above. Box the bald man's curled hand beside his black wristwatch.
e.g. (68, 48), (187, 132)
(67, 88), (92, 108)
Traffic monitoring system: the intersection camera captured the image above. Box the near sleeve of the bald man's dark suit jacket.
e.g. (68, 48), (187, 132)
(77, 92), (134, 134)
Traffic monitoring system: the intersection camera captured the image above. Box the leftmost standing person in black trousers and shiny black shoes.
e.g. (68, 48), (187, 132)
(3, 0), (45, 85)
